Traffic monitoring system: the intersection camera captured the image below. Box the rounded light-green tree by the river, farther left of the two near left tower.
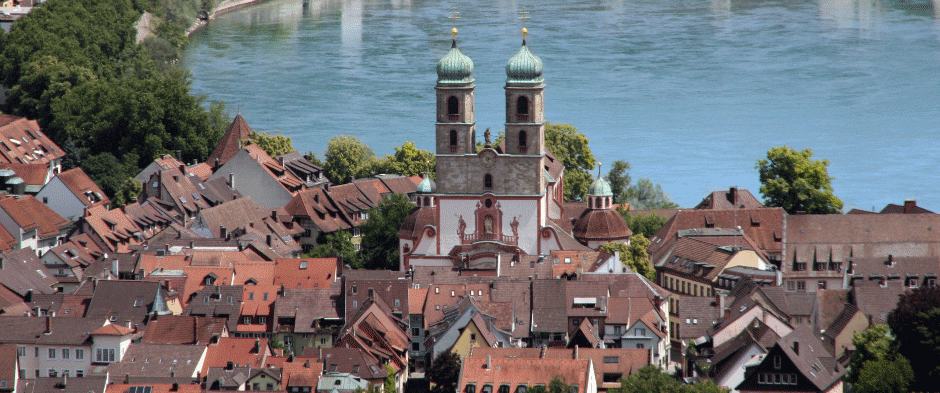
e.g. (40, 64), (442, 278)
(323, 135), (374, 184)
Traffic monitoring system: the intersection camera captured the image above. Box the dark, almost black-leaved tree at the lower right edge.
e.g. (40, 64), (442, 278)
(888, 286), (940, 391)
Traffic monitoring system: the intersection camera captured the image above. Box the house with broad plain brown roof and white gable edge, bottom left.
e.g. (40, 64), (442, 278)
(108, 343), (208, 382)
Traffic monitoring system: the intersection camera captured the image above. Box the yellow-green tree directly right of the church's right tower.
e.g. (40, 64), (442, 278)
(545, 122), (597, 200)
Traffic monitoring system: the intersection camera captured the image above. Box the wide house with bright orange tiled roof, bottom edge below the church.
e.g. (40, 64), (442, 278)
(457, 356), (597, 393)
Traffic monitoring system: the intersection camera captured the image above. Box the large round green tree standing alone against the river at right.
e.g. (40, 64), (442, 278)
(756, 146), (842, 214)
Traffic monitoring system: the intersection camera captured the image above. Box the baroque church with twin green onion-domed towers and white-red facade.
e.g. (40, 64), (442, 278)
(398, 23), (631, 271)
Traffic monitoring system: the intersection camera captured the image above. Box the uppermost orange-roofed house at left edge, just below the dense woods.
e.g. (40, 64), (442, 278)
(0, 115), (65, 173)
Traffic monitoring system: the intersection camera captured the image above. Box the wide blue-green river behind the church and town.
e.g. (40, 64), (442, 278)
(183, 0), (940, 212)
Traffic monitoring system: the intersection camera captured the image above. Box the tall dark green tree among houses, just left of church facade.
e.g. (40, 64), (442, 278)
(360, 194), (415, 270)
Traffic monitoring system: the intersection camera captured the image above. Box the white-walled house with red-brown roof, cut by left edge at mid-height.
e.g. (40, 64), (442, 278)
(0, 195), (70, 255)
